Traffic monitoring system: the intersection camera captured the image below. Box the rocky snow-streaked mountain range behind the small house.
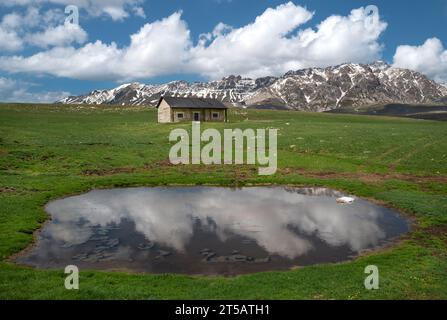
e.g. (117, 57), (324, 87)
(58, 61), (447, 111)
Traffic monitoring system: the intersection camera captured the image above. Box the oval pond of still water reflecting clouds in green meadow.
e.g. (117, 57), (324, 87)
(17, 186), (409, 276)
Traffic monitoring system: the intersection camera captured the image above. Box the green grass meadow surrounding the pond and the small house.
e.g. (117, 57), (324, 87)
(0, 105), (447, 299)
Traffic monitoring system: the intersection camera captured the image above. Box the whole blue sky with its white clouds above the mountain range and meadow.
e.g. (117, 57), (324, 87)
(0, 0), (447, 101)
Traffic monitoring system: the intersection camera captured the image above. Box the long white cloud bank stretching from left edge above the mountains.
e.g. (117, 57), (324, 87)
(0, 2), (386, 81)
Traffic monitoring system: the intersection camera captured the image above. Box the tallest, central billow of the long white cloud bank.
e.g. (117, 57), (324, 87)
(189, 2), (313, 78)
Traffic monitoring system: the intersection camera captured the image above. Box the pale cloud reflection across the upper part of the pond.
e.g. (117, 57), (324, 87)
(47, 187), (402, 259)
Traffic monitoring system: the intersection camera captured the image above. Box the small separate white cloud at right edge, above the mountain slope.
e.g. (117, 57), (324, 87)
(393, 38), (447, 82)
